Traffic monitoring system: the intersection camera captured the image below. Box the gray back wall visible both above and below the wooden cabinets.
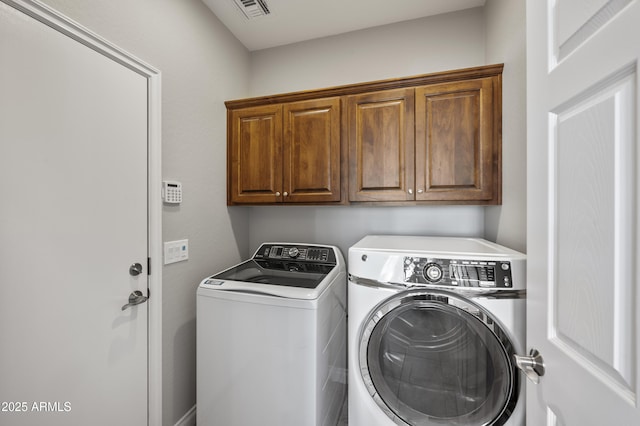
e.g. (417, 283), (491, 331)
(245, 8), (487, 257)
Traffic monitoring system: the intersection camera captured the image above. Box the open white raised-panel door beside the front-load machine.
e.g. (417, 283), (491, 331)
(527, 0), (640, 426)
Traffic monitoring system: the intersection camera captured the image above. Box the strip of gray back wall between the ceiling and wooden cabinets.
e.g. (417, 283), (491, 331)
(251, 8), (486, 96)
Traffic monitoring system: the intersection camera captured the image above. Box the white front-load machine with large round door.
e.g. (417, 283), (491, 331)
(348, 236), (525, 426)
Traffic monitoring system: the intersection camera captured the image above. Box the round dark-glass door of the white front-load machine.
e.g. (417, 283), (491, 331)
(359, 290), (519, 426)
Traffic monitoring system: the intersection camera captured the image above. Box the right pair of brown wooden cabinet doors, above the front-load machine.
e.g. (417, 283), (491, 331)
(347, 77), (502, 204)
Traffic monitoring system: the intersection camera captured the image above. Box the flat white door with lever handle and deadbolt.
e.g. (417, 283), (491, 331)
(0, 3), (148, 426)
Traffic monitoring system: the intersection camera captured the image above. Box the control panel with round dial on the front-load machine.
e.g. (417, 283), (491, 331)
(404, 256), (513, 288)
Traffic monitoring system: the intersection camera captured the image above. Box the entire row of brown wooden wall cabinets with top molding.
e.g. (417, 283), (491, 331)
(226, 64), (503, 205)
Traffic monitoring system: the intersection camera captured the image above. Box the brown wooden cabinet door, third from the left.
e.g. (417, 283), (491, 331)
(347, 89), (414, 201)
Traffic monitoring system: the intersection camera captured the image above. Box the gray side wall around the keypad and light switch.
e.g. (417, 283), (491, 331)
(37, 0), (250, 425)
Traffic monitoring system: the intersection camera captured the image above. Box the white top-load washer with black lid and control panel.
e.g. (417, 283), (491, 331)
(196, 243), (347, 426)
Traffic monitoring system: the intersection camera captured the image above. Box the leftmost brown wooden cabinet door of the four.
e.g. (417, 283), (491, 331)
(228, 105), (282, 204)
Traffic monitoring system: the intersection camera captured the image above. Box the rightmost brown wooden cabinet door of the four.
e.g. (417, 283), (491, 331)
(416, 77), (502, 204)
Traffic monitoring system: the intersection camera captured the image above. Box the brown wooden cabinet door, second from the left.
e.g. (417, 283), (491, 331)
(283, 98), (340, 203)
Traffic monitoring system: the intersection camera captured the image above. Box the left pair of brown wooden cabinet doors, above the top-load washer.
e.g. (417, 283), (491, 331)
(228, 98), (341, 204)
